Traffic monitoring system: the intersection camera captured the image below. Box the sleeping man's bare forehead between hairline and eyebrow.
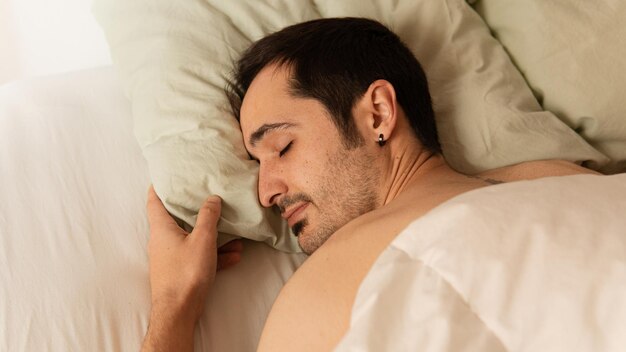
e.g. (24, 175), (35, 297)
(239, 65), (329, 142)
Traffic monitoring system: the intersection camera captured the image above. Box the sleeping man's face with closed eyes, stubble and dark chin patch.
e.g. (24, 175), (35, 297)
(240, 66), (380, 254)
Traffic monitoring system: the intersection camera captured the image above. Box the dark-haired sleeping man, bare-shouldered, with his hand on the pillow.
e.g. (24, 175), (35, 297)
(143, 18), (593, 351)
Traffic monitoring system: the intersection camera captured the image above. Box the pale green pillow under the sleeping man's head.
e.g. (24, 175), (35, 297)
(94, 0), (604, 250)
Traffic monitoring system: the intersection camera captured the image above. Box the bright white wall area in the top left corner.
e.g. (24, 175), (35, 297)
(0, 0), (111, 84)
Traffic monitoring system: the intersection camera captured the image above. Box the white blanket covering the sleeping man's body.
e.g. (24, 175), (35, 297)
(338, 174), (626, 352)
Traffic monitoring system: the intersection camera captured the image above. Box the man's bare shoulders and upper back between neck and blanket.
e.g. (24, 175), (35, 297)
(259, 161), (593, 351)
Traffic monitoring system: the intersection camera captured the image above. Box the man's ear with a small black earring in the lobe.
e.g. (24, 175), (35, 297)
(359, 79), (398, 142)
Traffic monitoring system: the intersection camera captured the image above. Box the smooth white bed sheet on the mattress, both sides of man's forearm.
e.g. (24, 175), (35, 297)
(0, 67), (305, 351)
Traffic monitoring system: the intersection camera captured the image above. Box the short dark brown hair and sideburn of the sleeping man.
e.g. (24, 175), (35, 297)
(226, 18), (441, 153)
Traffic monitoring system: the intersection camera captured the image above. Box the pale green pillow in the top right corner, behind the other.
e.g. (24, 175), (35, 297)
(476, 0), (626, 173)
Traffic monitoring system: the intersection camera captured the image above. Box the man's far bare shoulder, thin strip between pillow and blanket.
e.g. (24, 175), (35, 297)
(478, 160), (599, 182)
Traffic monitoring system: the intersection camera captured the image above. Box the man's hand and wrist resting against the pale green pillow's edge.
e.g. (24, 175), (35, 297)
(144, 186), (242, 350)
